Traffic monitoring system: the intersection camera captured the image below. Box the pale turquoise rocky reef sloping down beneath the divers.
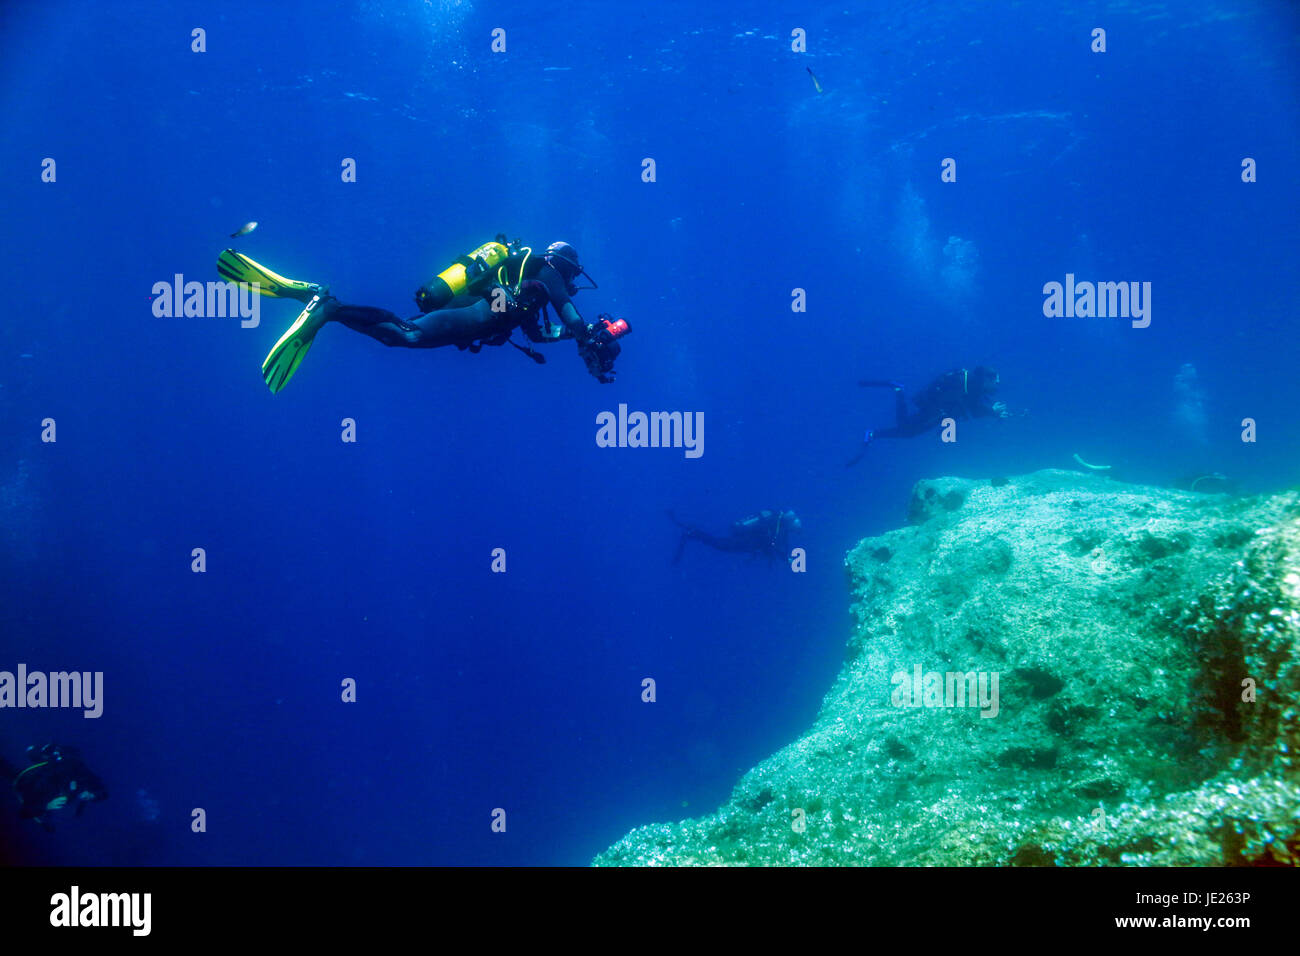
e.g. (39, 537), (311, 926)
(595, 471), (1300, 866)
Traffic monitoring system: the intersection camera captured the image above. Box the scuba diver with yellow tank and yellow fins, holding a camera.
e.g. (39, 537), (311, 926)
(217, 234), (631, 393)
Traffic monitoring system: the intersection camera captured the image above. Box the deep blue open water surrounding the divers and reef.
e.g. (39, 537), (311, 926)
(0, 0), (1300, 865)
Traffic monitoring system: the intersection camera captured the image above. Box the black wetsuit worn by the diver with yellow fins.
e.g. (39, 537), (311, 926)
(326, 255), (586, 351)
